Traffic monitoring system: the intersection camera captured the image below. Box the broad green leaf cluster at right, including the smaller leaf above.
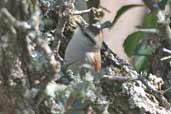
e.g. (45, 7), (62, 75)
(123, 13), (158, 71)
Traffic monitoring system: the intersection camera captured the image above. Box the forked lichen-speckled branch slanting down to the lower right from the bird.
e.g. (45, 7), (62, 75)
(103, 43), (171, 108)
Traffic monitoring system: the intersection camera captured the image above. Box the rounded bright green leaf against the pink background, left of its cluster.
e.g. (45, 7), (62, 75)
(123, 32), (144, 57)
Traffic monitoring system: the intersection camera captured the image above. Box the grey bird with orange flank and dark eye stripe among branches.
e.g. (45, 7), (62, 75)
(64, 21), (111, 74)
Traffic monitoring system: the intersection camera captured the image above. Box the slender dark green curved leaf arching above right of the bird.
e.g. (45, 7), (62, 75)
(112, 4), (144, 26)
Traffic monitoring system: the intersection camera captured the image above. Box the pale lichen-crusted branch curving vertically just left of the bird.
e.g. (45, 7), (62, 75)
(35, 38), (60, 106)
